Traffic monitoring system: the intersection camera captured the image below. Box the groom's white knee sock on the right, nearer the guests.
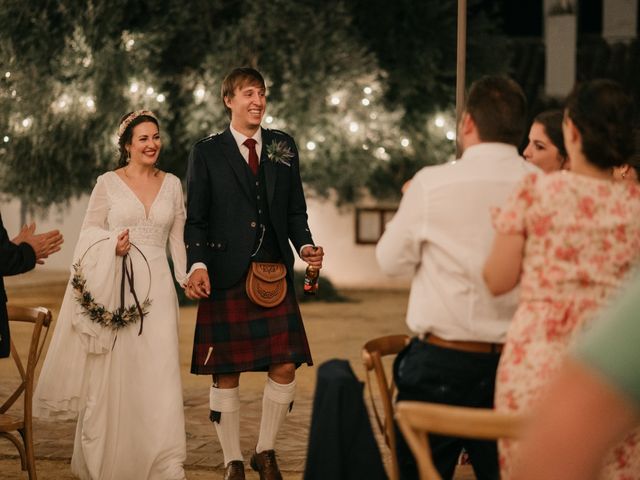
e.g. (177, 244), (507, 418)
(256, 377), (296, 453)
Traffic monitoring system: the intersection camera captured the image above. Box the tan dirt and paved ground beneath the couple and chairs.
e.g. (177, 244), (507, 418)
(0, 272), (474, 480)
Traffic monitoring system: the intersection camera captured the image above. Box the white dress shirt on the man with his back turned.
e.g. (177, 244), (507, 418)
(376, 143), (538, 343)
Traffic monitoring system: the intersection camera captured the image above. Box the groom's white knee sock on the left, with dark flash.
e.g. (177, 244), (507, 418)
(209, 387), (243, 465)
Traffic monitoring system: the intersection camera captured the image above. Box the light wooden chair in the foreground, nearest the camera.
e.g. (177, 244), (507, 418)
(396, 401), (525, 480)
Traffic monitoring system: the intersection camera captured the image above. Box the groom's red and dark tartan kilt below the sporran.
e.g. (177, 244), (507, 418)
(191, 275), (313, 375)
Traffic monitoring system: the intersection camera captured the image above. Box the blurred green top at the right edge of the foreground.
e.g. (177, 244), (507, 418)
(573, 275), (640, 407)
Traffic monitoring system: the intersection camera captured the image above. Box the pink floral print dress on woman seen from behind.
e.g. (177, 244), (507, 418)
(494, 171), (640, 480)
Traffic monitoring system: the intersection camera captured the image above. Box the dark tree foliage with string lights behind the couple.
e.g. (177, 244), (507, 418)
(0, 0), (510, 207)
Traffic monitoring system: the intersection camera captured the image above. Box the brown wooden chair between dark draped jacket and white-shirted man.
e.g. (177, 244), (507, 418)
(362, 335), (409, 480)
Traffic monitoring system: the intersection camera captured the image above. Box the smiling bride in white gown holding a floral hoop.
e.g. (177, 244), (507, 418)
(34, 110), (186, 480)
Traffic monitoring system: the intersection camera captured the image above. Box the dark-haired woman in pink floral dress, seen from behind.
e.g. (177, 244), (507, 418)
(484, 80), (640, 479)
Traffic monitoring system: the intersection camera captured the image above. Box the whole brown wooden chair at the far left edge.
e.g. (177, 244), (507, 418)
(0, 305), (51, 480)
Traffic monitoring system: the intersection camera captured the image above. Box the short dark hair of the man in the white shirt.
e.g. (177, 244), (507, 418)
(465, 75), (527, 147)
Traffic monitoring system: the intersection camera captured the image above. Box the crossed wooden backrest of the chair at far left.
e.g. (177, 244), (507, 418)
(0, 305), (51, 421)
